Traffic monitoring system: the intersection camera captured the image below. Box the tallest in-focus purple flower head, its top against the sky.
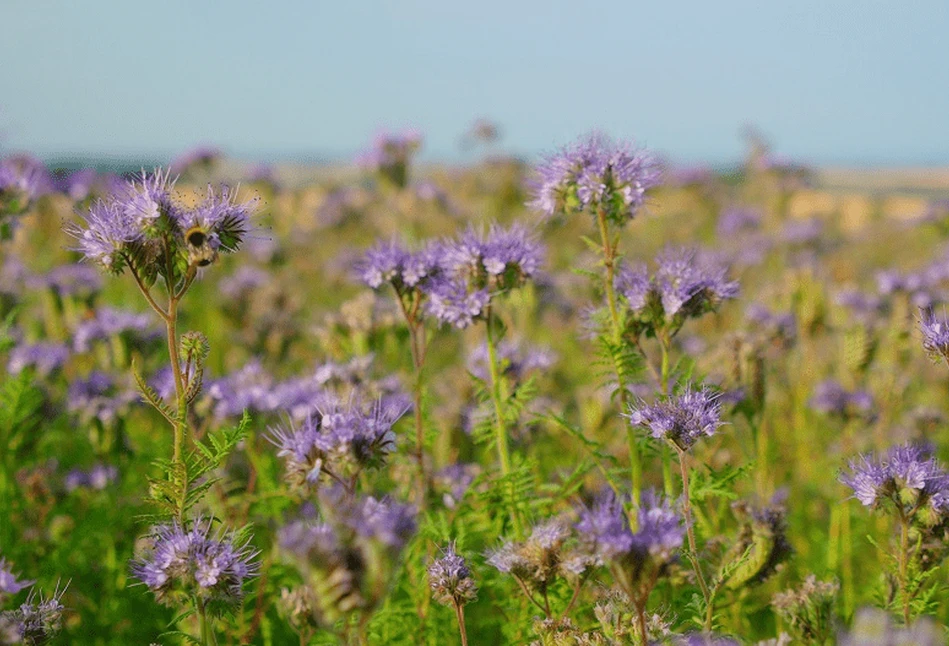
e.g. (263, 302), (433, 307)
(530, 133), (661, 224)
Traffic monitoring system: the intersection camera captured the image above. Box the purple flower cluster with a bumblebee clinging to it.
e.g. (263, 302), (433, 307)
(66, 169), (257, 273)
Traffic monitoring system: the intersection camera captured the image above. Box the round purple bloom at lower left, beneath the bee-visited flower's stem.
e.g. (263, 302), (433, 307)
(132, 519), (258, 606)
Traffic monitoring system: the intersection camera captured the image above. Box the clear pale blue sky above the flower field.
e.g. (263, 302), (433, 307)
(0, 0), (949, 165)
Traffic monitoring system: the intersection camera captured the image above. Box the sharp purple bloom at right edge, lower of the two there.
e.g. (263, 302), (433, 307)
(840, 444), (949, 514)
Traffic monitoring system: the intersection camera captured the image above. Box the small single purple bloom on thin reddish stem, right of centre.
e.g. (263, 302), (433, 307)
(628, 387), (723, 451)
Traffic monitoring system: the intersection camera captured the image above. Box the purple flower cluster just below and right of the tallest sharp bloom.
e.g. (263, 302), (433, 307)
(614, 248), (738, 333)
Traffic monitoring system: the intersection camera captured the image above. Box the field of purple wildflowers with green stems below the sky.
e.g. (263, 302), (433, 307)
(0, 133), (949, 646)
